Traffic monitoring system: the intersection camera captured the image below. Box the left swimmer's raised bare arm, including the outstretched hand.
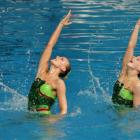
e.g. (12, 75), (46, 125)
(36, 10), (71, 77)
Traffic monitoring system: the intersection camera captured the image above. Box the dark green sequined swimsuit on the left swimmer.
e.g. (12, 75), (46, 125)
(28, 78), (56, 114)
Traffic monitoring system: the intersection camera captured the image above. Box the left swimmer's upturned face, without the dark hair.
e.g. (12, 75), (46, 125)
(51, 56), (70, 72)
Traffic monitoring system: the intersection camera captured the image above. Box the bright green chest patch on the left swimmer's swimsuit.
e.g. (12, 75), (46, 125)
(40, 83), (56, 100)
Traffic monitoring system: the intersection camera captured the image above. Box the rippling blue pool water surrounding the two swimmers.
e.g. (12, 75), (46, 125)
(0, 0), (140, 140)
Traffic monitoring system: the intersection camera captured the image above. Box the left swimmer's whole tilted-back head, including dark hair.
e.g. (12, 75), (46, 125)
(51, 56), (71, 78)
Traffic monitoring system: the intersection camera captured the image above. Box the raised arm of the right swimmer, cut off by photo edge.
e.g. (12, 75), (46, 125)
(120, 20), (140, 76)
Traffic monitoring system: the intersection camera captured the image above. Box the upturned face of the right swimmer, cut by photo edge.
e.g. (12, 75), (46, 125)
(127, 56), (140, 71)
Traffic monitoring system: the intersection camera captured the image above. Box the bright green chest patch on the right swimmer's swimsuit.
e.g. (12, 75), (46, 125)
(119, 87), (133, 101)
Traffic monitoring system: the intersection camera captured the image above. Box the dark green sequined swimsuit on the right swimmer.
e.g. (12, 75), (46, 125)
(112, 81), (133, 107)
